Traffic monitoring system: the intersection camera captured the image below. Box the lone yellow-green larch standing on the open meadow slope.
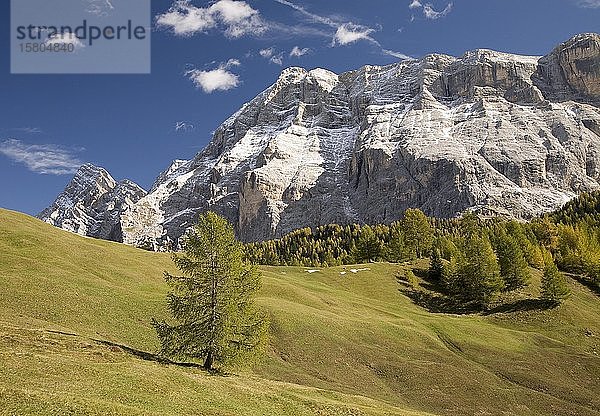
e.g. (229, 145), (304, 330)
(152, 212), (267, 370)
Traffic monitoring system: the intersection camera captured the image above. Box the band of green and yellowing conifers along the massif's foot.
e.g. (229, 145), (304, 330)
(245, 192), (600, 305)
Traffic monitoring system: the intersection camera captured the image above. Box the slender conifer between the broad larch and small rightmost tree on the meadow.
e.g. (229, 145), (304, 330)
(495, 231), (531, 291)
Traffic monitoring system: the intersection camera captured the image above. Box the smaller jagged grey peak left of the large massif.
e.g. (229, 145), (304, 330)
(39, 164), (147, 241)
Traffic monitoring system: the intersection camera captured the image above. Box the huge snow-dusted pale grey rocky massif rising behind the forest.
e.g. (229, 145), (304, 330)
(41, 34), (600, 245)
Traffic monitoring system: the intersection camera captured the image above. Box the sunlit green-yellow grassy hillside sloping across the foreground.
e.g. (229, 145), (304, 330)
(0, 210), (600, 415)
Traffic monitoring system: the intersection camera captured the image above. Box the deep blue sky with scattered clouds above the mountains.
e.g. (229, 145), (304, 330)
(0, 0), (600, 214)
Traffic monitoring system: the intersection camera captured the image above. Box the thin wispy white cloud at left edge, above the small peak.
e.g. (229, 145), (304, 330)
(0, 139), (82, 175)
